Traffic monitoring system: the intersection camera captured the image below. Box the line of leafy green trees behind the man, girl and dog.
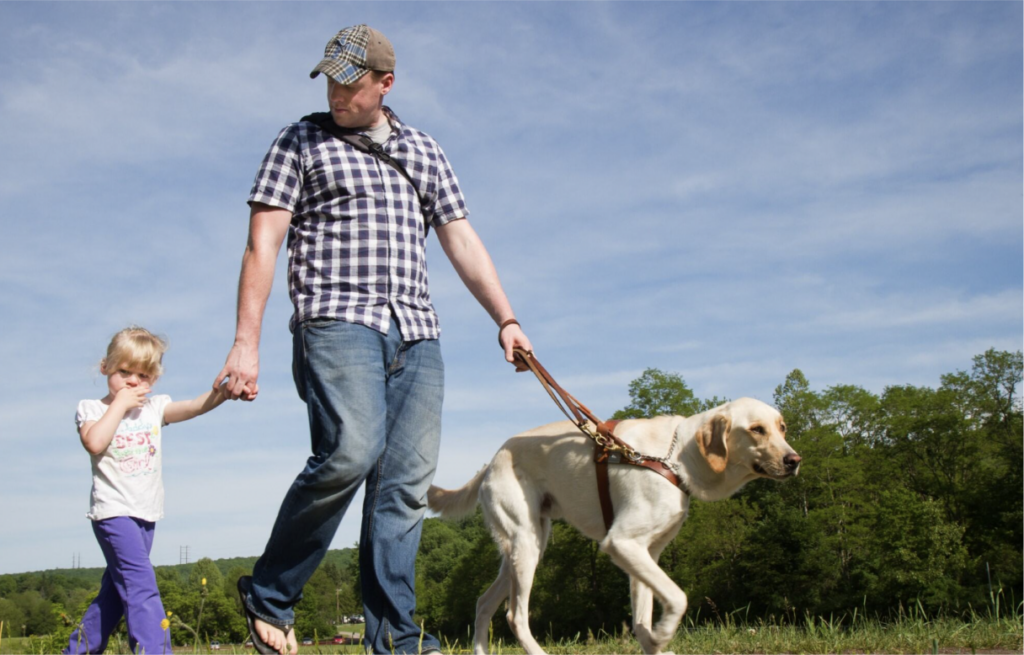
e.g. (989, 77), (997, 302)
(6, 350), (1024, 644)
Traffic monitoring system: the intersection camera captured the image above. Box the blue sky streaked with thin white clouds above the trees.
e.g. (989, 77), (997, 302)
(0, 0), (1024, 573)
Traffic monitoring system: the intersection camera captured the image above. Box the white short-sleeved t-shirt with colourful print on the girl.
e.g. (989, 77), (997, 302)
(75, 395), (171, 521)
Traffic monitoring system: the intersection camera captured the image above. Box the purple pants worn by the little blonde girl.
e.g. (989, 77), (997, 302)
(63, 516), (171, 655)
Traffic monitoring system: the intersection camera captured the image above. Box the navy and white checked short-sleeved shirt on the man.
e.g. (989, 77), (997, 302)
(249, 107), (469, 341)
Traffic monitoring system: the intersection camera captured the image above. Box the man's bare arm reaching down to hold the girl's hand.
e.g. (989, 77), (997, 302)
(213, 203), (292, 399)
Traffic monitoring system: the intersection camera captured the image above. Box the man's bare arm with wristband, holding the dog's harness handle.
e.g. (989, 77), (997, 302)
(437, 219), (532, 361)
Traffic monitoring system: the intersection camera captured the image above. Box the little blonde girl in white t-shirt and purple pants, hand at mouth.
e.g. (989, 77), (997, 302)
(65, 326), (256, 655)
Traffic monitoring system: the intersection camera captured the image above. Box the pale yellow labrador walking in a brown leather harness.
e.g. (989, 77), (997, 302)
(427, 398), (800, 655)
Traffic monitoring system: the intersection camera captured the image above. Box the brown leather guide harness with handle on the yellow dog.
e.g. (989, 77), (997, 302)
(513, 348), (690, 530)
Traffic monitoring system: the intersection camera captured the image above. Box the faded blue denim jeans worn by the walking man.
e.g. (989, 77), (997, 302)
(249, 318), (444, 655)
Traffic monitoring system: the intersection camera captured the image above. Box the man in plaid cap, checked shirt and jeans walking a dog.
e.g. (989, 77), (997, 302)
(214, 25), (530, 655)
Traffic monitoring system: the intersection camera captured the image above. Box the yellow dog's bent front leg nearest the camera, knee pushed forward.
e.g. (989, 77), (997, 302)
(601, 540), (686, 655)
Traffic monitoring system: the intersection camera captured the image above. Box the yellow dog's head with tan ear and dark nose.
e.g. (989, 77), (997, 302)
(696, 398), (800, 480)
